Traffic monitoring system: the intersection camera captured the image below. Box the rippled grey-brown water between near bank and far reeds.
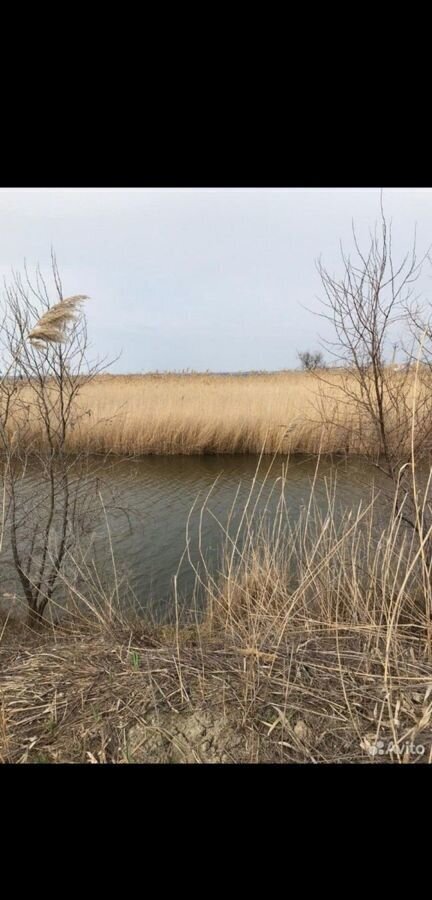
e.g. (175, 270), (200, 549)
(2, 455), (392, 624)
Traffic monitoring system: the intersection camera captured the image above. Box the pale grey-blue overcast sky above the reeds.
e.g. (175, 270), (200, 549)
(0, 187), (432, 372)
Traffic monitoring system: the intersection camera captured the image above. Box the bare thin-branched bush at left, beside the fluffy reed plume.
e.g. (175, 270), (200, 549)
(0, 255), (111, 624)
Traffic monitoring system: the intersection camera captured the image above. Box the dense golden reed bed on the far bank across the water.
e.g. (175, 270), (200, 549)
(10, 370), (428, 455)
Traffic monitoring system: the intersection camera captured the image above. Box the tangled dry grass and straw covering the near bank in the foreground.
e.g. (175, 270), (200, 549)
(0, 460), (432, 763)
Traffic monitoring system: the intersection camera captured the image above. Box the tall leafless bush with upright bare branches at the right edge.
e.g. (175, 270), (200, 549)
(308, 205), (432, 648)
